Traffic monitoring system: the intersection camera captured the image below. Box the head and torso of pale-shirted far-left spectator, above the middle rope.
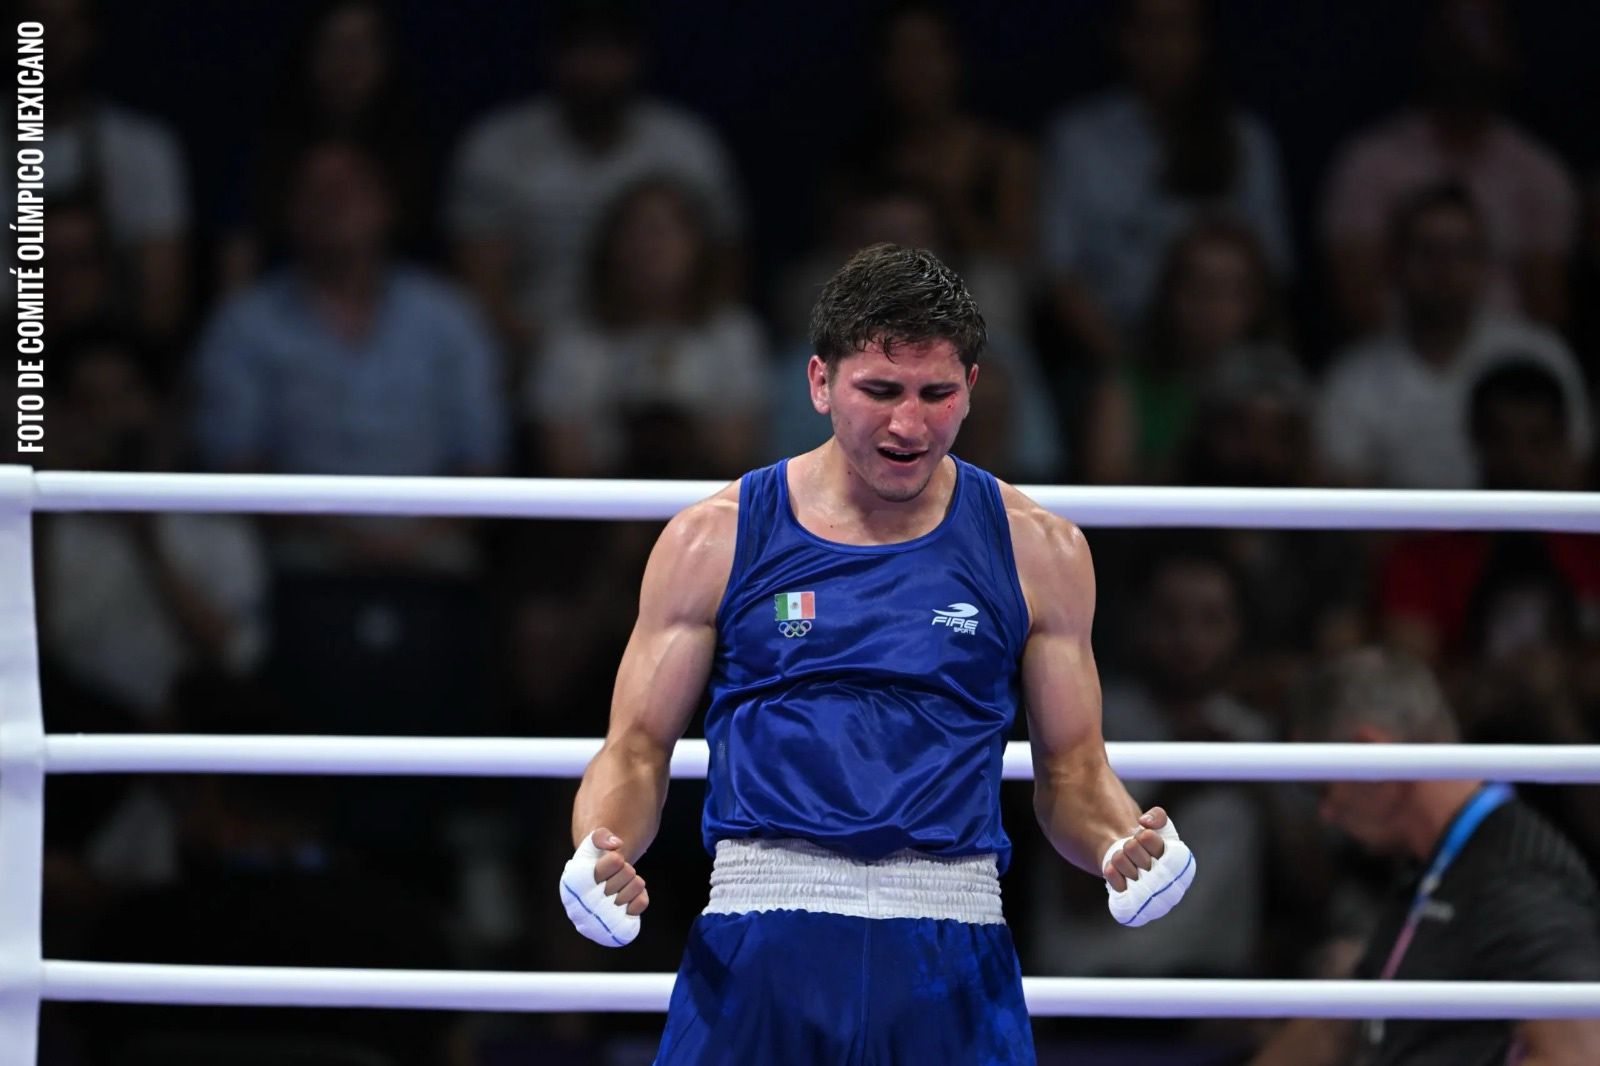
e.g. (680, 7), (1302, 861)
(38, 328), (266, 725)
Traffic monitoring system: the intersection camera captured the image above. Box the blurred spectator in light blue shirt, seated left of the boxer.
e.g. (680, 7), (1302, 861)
(195, 141), (506, 877)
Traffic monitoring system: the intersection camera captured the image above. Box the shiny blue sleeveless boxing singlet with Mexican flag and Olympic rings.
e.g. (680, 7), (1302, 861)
(701, 456), (1027, 872)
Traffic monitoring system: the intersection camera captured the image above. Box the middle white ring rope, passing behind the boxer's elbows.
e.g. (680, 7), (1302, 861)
(34, 733), (1600, 784)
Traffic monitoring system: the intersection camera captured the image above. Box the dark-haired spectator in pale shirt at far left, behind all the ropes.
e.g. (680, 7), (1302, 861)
(34, 326), (267, 954)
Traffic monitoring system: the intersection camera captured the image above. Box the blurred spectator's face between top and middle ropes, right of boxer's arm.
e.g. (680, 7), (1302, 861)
(1141, 559), (1240, 699)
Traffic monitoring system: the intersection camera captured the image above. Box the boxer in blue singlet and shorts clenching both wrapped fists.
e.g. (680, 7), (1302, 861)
(560, 245), (1195, 1064)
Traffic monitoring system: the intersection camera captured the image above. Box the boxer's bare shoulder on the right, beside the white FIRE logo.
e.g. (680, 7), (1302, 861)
(1000, 482), (1094, 631)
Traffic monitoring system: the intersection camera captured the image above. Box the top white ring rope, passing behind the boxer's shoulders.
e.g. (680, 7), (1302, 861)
(21, 471), (1600, 533)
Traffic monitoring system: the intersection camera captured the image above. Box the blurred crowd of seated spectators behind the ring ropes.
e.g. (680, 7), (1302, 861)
(19, 0), (1600, 1066)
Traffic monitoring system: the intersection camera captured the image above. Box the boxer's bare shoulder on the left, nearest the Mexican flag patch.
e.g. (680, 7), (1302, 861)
(640, 482), (739, 624)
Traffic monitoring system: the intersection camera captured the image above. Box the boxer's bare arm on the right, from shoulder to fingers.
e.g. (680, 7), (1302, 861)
(1002, 485), (1162, 890)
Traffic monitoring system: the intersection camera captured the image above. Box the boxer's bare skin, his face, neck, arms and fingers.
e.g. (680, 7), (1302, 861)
(571, 339), (1166, 914)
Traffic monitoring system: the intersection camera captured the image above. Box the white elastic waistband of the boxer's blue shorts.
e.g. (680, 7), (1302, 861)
(706, 840), (1005, 925)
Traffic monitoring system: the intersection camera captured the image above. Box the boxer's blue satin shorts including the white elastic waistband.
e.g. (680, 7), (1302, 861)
(656, 840), (1034, 1066)
